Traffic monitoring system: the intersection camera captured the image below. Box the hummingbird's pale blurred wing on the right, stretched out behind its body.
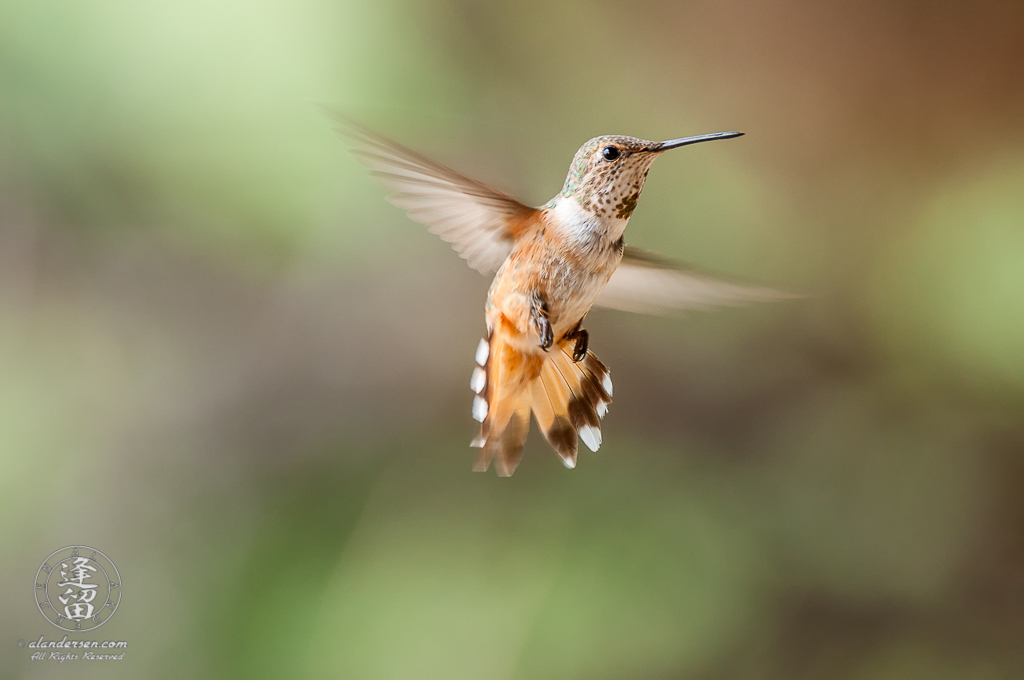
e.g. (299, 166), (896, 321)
(595, 247), (803, 314)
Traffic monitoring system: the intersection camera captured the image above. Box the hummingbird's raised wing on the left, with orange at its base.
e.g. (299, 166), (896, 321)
(335, 117), (537, 273)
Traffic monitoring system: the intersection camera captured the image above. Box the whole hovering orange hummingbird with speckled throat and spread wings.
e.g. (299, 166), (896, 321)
(338, 119), (793, 476)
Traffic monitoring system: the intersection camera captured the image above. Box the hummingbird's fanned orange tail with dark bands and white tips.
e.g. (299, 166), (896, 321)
(470, 320), (611, 477)
